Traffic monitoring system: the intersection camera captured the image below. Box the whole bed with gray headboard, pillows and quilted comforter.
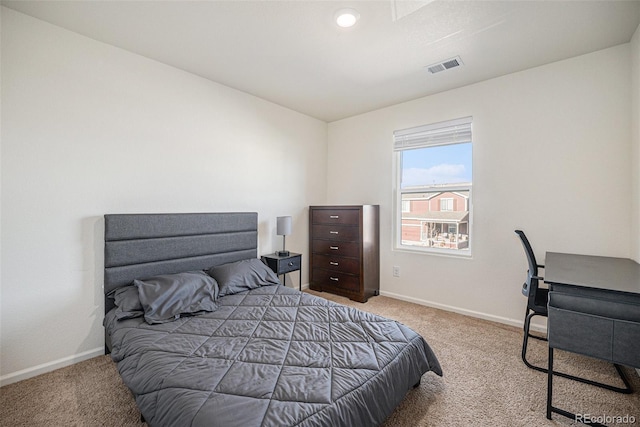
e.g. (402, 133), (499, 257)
(104, 212), (442, 427)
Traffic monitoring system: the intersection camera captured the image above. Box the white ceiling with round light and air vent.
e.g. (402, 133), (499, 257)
(2, 0), (640, 122)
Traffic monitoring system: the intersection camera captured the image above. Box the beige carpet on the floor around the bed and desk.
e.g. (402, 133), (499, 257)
(0, 292), (640, 427)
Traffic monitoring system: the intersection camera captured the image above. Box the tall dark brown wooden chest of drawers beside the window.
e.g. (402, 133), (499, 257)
(309, 205), (380, 302)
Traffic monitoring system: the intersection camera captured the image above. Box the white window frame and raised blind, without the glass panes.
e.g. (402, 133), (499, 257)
(392, 117), (474, 258)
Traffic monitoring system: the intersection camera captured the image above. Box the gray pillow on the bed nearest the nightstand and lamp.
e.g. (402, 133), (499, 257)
(207, 258), (280, 297)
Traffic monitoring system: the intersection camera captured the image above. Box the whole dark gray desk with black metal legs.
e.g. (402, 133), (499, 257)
(544, 252), (640, 425)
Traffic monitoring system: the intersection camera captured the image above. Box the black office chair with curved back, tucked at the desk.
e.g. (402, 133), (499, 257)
(515, 230), (633, 394)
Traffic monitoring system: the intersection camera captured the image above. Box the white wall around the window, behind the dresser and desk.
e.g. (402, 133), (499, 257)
(327, 44), (632, 325)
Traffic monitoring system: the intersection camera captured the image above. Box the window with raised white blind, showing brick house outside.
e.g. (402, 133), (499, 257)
(393, 117), (472, 256)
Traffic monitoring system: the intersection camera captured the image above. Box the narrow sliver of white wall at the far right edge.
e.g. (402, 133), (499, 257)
(631, 26), (640, 262)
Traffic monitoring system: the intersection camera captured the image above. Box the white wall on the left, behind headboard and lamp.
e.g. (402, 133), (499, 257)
(0, 8), (327, 384)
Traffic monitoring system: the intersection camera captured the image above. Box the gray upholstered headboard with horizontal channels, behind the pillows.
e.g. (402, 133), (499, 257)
(104, 212), (258, 313)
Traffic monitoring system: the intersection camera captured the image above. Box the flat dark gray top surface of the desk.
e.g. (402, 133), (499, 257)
(544, 252), (640, 294)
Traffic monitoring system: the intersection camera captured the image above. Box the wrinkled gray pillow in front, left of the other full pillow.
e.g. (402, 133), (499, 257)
(133, 271), (218, 324)
